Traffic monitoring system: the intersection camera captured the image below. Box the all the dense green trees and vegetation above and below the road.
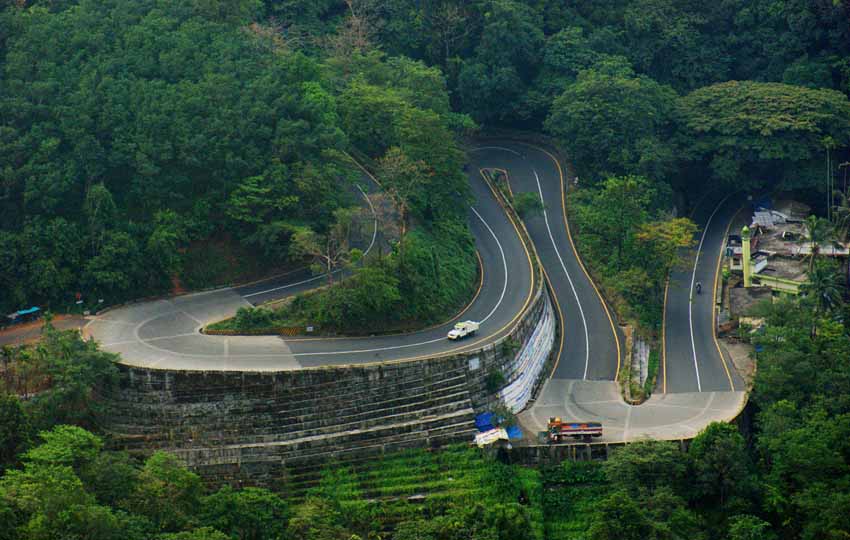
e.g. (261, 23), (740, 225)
(0, 0), (850, 540)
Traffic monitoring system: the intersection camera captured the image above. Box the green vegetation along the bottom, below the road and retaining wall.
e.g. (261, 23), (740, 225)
(6, 299), (850, 540)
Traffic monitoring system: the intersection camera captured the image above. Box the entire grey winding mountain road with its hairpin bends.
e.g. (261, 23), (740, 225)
(86, 141), (746, 441)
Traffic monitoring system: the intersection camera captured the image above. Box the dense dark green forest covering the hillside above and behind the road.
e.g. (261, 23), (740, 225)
(0, 0), (850, 327)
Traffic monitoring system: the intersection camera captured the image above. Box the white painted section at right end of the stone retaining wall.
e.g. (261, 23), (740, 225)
(499, 298), (555, 413)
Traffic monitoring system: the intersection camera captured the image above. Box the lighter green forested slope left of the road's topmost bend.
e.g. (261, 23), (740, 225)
(0, 1), (475, 330)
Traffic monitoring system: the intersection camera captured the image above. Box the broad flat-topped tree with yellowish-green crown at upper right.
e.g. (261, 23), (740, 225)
(677, 81), (850, 188)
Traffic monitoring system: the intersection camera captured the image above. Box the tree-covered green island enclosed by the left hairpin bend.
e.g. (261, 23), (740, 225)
(232, 215), (477, 333)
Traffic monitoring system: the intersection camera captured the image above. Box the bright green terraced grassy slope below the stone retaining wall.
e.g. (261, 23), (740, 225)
(289, 446), (542, 540)
